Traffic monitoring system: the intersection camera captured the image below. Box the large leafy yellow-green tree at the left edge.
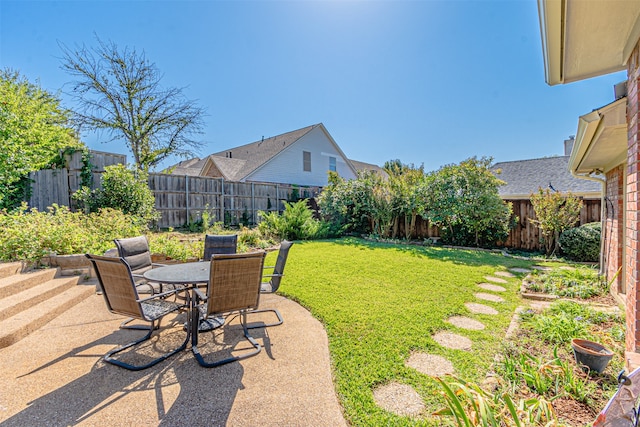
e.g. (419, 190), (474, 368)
(0, 69), (82, 208)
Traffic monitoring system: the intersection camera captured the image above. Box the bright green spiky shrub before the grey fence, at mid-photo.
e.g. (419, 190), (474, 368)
(258, 200), (329, 240)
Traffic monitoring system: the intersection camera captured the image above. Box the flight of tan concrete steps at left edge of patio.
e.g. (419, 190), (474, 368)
(0, 263), (95, 349)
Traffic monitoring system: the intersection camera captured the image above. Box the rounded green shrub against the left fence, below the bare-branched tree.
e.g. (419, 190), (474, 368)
(73, 165), (159, 225)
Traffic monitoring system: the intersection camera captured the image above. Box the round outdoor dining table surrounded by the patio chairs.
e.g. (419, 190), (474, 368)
(143, 261), (224, 331)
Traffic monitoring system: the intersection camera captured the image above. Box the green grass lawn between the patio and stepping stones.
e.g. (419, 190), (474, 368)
(271, 238), (531, 426)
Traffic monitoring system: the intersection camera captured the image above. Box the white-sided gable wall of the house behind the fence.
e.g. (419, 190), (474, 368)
(246, 127), (356, 186)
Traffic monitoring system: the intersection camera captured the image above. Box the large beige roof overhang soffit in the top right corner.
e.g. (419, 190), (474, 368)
(538, 0), (640, 85)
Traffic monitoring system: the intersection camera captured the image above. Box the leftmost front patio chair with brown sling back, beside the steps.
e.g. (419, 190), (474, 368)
(86, 254), (190, 371)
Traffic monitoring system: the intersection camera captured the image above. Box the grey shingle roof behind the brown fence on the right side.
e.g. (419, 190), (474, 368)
(491, 156), (602, 199)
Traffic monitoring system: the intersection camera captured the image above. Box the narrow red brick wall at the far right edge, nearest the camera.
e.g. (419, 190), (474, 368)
(625, 41), (640, 352)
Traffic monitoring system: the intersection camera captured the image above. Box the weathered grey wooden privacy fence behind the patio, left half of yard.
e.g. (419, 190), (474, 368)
(28, 151), (320, 228)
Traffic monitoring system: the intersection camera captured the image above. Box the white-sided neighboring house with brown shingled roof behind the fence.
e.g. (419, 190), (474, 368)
(168, 123), (381, 187)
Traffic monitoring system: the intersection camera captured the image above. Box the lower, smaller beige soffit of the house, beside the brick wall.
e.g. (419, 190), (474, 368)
(569, 98), (627, 174)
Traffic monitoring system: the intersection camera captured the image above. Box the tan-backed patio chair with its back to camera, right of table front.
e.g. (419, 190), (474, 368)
(191, 251), (266, 368)
